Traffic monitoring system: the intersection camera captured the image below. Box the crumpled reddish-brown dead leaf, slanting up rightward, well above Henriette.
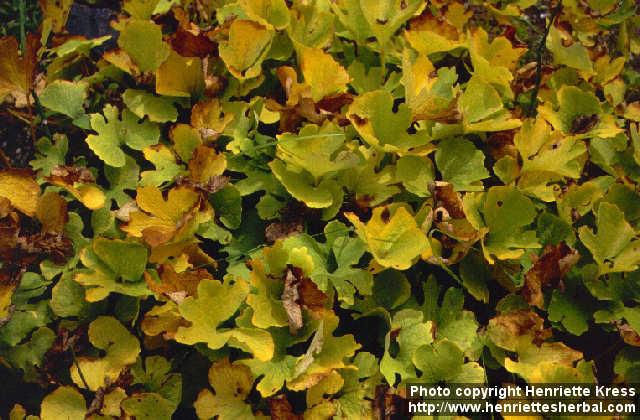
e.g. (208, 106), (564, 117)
(522, 242), (580, 309)
